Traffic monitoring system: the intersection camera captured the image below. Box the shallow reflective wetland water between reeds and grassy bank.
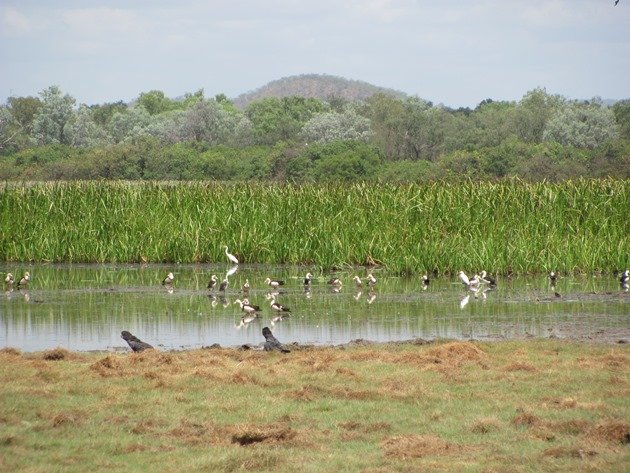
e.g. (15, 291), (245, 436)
(0, 263), (630, 351)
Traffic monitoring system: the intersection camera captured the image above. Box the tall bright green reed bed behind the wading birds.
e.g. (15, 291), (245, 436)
(0, 179), (630, 274)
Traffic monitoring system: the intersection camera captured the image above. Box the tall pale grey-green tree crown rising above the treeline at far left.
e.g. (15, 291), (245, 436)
(32, 85), (75, 145)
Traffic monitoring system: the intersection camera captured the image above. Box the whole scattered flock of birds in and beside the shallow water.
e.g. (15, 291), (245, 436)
(4, 246), (630, 353)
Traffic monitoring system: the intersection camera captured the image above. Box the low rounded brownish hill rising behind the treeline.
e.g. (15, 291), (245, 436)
(234, 74), (406, 108)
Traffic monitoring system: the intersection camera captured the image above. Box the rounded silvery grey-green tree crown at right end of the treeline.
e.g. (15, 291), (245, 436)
(543, 99), (619, 149)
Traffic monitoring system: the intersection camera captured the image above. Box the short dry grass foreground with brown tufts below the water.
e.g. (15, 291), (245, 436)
(0, 340), (630, 472)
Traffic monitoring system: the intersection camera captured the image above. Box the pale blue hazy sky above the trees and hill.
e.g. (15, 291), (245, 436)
(0, 0), (630, 107)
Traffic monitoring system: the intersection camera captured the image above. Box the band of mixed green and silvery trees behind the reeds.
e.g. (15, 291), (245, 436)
(0, 86), (630, 182)
